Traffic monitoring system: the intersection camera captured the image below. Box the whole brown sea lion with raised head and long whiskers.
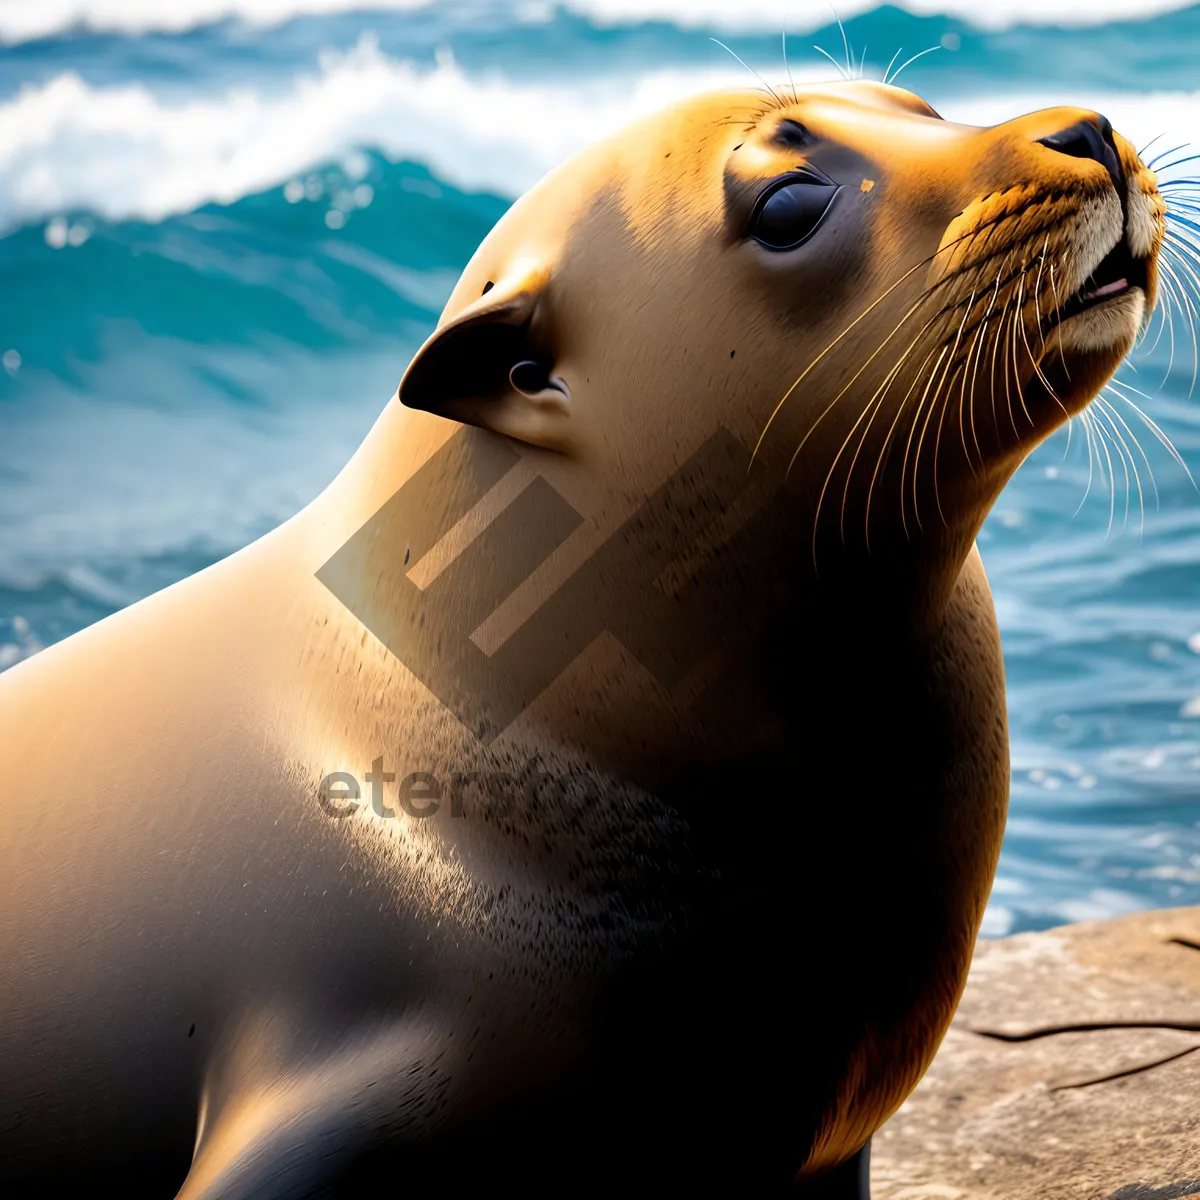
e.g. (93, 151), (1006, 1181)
(0, 82), (1164, 1200)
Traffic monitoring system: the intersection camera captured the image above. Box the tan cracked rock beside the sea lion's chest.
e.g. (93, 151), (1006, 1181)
(871, 907), (1200, 1200)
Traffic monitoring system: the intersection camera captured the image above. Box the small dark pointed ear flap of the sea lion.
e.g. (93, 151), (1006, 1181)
(400, 271), (571, 449)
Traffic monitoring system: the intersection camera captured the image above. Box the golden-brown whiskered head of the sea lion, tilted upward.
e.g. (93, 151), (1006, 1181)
(400, 82), (1164, 600)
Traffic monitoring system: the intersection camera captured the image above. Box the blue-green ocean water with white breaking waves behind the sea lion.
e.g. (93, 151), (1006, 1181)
(0, 0), (1200, 935)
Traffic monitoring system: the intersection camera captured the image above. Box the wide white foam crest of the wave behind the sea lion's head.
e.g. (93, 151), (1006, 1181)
(0, 38), (1200, 228)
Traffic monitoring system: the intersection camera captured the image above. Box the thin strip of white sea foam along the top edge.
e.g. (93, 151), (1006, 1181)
(0, 0), (1193, 42)
